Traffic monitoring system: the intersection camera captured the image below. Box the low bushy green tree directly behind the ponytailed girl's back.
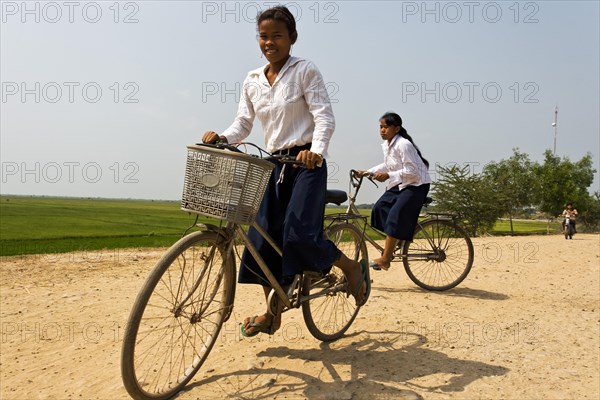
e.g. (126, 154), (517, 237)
(432, 165), (503, 236)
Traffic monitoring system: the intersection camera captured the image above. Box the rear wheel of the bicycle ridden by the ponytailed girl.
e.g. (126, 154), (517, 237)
(402, 219), (474, 291)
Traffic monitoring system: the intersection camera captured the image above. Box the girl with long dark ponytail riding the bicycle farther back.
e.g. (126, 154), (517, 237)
(358, 112), (431, 270)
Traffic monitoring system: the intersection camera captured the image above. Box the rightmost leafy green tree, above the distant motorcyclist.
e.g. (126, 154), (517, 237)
(534, 150), (596, 218)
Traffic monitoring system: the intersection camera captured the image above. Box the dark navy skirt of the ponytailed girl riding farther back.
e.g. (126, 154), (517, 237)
(371, 183), (429, 240)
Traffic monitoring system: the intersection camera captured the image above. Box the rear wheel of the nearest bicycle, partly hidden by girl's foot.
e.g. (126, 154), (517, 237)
(302, 223), (368, 342)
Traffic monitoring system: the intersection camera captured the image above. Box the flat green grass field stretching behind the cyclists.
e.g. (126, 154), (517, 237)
(0, 195), (560, 256)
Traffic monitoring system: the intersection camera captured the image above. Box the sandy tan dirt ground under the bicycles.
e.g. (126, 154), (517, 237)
(0, 234), (600, 400)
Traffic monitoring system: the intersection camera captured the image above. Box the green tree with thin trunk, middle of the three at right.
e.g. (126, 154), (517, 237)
(483, 148), (536, 235)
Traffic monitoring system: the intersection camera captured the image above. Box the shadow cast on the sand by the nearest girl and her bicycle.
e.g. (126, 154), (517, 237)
(186, 331), (509, 400)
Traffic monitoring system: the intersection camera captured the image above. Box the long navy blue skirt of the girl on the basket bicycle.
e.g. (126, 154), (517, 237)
(238, 161), (341, 286)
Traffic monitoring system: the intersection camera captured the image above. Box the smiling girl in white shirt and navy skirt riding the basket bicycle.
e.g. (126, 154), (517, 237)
(202, 6), (370, 336)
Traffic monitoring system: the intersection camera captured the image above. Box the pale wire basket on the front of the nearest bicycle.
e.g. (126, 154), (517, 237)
(181, 145), (275, 224)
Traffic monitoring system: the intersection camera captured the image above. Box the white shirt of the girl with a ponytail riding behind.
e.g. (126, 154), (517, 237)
(368, 135), (431, 190)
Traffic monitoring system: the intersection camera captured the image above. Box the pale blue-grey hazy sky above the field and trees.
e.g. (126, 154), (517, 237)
(0, 1), (600, 203)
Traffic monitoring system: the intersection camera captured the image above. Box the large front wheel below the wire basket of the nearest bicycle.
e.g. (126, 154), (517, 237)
(121, 232), (235, 400)
